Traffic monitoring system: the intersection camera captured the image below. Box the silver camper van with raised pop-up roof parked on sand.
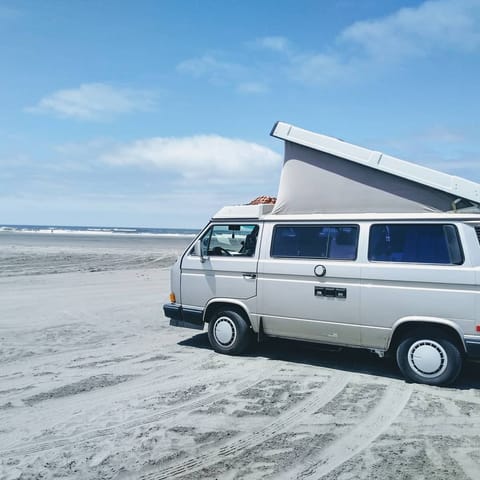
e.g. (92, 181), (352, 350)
(164, 122), (480, 385)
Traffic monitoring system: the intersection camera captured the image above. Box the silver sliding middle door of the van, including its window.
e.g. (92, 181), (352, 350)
(258, 223), (361, 345)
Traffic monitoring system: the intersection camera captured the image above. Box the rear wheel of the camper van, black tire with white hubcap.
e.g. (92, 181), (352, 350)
(397, 330), (463, 385)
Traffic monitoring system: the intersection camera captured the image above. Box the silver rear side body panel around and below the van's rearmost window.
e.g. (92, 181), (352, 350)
(361, 221), (479, 348)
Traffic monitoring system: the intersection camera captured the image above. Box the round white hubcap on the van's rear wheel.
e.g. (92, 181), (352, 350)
(408, 340), (448, 378)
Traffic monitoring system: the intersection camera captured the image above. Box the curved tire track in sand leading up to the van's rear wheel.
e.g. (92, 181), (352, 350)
(289, 384), (413, 480)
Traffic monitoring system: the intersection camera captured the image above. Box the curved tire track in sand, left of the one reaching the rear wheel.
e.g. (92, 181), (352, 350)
(140, 372), (350, 480)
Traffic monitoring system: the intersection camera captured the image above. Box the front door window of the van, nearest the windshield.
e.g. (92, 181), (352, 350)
(194, 224), (259, 257)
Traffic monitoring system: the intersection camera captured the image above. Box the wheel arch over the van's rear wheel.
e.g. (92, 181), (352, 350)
(387, 317), (466, 354)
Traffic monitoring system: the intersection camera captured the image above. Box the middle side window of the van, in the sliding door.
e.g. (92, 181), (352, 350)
(270, 225), (358, 260)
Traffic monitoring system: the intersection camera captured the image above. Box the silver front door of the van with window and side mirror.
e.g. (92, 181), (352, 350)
(180, 223), (260, 311)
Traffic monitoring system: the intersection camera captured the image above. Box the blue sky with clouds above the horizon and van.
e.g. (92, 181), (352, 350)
(0, 0), (480, 228)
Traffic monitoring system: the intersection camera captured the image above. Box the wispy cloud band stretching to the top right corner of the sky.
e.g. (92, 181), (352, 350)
(177, 0), (480, 88)
